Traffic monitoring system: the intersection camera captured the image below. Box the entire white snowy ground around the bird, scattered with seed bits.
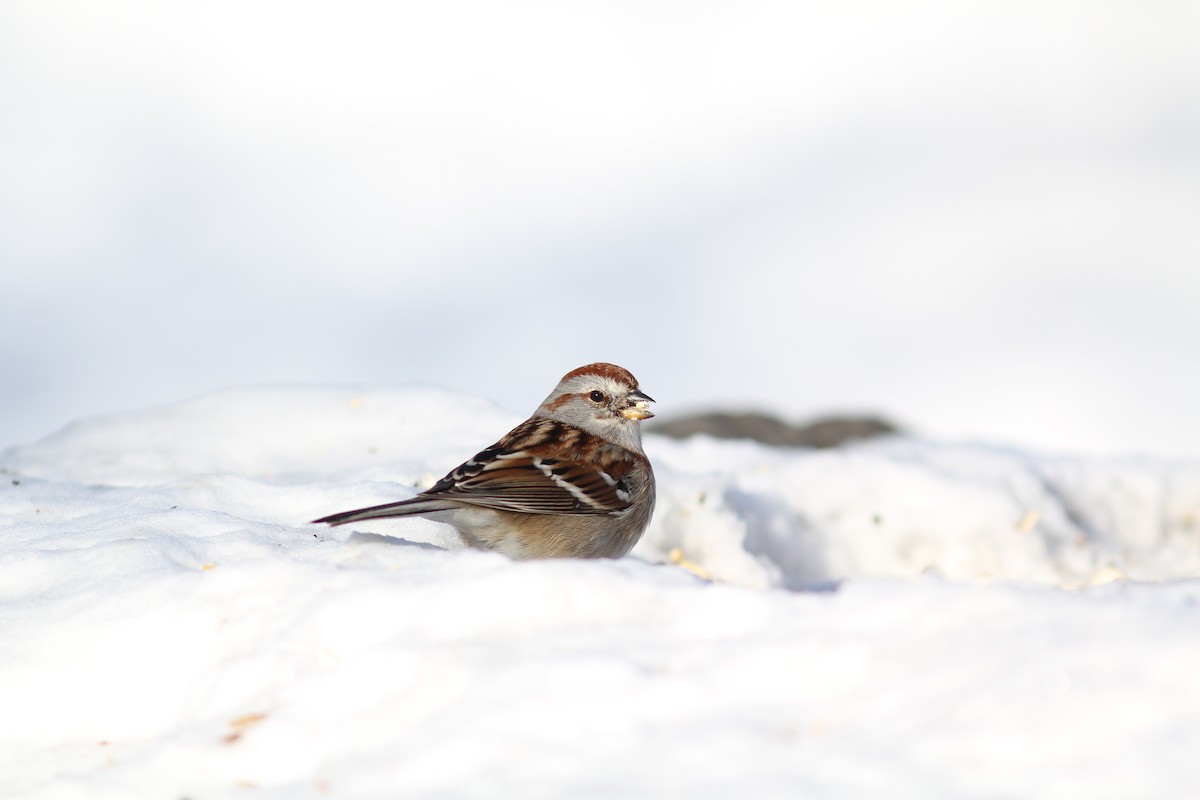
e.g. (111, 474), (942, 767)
(0, 387), (1200, 800)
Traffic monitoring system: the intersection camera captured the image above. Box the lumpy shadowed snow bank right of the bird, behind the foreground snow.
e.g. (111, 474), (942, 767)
(652, 438), (1200, 588)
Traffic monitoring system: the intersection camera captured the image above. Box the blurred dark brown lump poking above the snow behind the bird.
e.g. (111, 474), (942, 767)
(646, 411), (899, 447)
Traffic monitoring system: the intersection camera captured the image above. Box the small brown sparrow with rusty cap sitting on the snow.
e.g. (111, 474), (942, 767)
(314, 363), (654, 559)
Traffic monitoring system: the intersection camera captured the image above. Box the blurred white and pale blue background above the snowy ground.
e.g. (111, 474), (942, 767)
(0, 0), (1200, 457)
